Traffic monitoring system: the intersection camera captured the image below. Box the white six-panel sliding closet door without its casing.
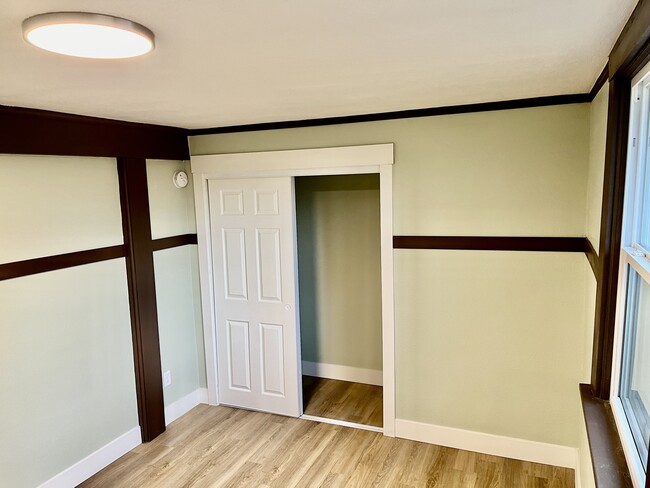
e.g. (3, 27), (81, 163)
(208, 177), (302, 417)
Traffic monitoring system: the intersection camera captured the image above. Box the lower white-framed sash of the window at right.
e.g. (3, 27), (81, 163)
(620, 267), (650, 470)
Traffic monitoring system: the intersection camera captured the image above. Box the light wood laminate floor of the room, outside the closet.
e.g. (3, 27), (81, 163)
(81, 405), (573, 488)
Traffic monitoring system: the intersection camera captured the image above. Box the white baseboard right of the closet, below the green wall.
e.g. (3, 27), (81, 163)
(395, 419), (578, 469)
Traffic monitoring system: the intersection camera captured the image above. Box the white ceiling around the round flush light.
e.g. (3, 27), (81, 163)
(0, 0), (636, 128)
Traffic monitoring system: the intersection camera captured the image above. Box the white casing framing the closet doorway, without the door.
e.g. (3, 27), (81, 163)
(191, 143), (395, 437)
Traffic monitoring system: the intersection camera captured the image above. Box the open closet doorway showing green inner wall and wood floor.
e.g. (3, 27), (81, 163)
(295, 173), (383, 431)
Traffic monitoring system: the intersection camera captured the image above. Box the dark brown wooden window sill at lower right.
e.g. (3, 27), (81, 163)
(580, 384), (632, 488)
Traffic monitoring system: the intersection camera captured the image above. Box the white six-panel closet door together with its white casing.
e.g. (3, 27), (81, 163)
(191, 144), (395, 437)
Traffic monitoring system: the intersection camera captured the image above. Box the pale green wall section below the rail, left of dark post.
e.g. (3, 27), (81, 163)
(0, 259), (138, 488)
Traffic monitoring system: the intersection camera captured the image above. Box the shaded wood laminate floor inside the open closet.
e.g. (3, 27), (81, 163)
(302, 376), (384, 427)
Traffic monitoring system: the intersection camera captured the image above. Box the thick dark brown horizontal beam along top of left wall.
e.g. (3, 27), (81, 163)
(0, 105), (189, 159)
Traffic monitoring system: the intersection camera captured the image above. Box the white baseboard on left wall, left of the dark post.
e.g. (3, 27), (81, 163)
(39, 427), (142, 488)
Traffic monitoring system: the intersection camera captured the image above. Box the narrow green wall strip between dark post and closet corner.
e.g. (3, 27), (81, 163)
(147, 160), (206, 406)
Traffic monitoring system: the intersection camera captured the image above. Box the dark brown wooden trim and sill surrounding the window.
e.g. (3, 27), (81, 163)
(580, 0), (650, 488)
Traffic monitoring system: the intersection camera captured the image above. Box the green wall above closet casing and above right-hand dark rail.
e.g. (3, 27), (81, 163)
(190, 104), (589, 236)
